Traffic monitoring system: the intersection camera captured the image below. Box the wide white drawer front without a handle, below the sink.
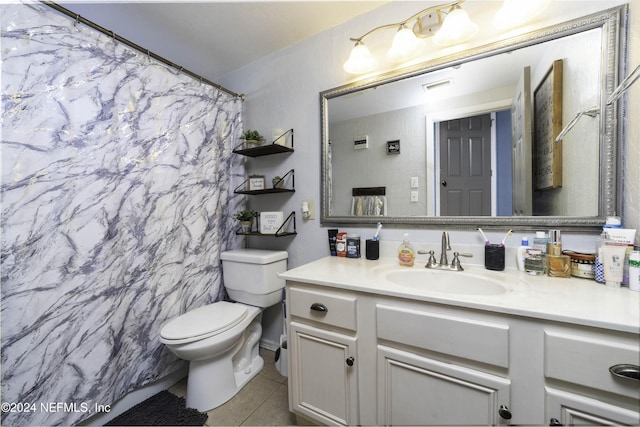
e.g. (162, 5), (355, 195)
(376, 305), (509, 368)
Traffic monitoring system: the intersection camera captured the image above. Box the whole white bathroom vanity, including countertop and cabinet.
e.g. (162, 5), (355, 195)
(280, 257), (640, 425)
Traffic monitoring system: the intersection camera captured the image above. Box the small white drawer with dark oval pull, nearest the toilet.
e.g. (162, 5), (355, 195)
(287, 286), (356, 331)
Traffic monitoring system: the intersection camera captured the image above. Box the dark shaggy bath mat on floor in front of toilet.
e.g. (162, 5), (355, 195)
(105, 390), (208, 426)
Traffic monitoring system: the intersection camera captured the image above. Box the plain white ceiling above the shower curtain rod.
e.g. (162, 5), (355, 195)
(59, 0), (388, 82)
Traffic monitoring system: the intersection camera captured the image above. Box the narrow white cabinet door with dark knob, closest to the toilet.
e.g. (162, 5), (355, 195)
(289, 322), (358, 425)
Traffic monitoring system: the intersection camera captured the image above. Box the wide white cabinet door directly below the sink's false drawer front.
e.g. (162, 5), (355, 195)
(378, 346), (510, 425)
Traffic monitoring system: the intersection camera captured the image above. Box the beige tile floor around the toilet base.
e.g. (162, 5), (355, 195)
(169, 348), (296, 426)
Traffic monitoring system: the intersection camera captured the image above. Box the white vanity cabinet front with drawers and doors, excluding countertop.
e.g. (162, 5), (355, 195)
(286, 274), (640, 425)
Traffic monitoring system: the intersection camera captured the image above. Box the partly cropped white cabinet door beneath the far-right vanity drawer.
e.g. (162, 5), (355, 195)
(545, 387), (640, 426)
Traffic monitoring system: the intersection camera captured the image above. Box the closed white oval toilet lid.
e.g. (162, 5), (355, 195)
(160, 301), (248, 340)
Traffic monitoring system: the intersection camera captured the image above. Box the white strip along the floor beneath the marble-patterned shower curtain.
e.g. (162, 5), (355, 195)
(78, 365), (189, 426)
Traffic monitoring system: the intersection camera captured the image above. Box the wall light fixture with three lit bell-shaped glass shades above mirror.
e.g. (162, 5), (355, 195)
(343, 0), (478, 74)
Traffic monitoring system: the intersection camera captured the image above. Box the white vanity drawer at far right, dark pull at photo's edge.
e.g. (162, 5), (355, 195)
(544, 330), (640, 399)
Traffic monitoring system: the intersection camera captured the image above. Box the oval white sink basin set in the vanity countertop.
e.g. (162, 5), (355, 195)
(386, 268), (508, 295)
